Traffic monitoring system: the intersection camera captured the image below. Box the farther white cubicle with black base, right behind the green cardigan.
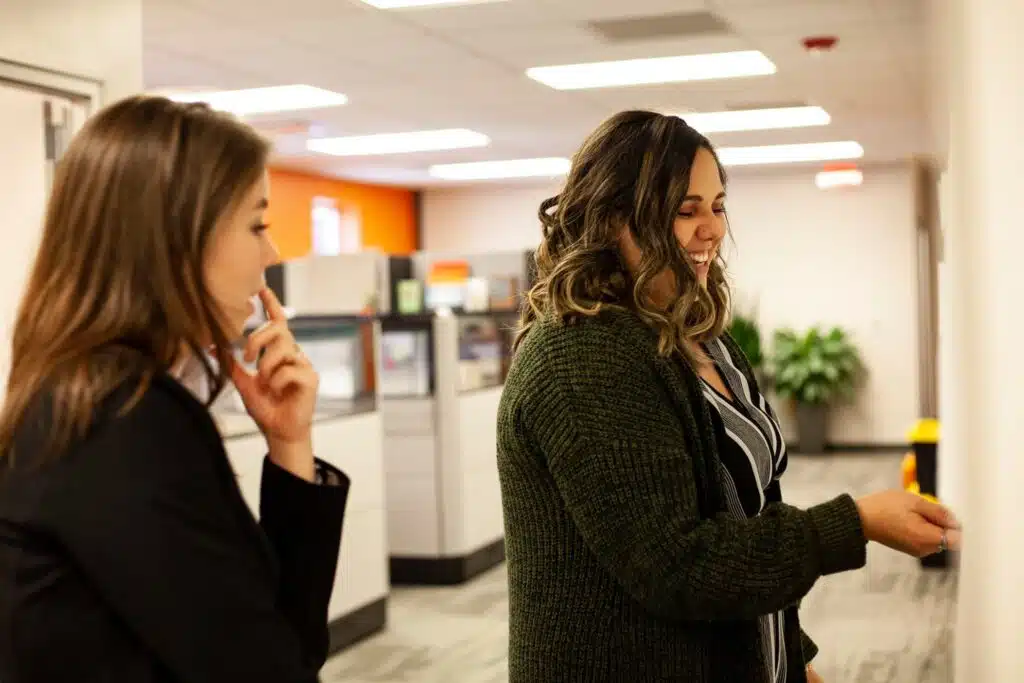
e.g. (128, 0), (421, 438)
(267, 252), (531, 584)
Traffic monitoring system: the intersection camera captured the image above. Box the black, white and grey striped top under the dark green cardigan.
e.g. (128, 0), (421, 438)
(701, 339), (786, 683)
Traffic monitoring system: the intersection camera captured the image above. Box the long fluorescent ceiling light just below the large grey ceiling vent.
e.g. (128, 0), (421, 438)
(526, 50), (775, 90)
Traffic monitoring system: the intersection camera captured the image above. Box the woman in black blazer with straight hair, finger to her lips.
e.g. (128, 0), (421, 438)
(0, 97), (348, 683)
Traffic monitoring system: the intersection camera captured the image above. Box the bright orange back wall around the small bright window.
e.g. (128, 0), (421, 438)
(267, 169), (417, 260)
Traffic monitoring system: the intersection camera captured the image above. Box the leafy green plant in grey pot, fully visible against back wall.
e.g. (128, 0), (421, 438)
(771, 327), (864, 453)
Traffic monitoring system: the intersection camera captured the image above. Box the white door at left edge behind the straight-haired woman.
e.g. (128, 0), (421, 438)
(0, 83), (86, 386)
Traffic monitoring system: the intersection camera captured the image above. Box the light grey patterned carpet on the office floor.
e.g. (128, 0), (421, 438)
(323, 454), (955, 683)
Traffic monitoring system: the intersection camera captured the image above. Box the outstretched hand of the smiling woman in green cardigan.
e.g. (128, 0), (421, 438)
(857, 490), (961, 557)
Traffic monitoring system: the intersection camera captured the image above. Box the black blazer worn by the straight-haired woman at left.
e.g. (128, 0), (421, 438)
(0, 377), (349, 683)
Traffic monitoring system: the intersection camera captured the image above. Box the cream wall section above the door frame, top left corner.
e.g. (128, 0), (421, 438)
(0, 0), (142, 101)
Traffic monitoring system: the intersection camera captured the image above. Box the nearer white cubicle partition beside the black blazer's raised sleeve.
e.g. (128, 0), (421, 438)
(214, 316), (390, 652)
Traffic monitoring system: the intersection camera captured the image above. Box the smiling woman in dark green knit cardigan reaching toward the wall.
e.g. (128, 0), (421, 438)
(498, 112), (959, 683)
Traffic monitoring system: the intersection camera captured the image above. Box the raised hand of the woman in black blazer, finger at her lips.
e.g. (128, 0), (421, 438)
(231, 289), (319, 481)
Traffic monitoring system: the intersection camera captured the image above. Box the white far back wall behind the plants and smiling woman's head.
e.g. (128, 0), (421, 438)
(423, 167), (919, 444)
